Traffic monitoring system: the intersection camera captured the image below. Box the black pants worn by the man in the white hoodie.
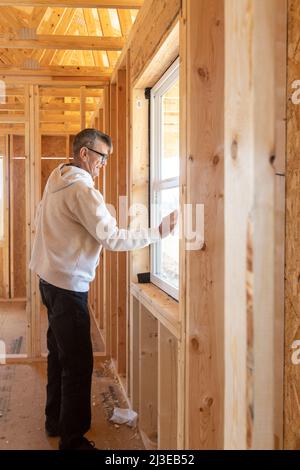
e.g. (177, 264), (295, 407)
(40, 280), (93, 446)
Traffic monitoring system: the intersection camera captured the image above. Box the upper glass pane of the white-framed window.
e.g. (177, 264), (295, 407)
(161, 80), (179, 179)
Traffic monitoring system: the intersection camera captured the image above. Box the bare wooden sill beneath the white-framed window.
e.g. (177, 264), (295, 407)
(130, 282), (181, 340)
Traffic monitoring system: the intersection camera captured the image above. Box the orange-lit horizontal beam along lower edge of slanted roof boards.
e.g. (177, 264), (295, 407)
(0, 65), (113, 77)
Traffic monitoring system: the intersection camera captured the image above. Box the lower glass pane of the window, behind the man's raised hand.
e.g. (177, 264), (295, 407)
(156, 187), (179, 289)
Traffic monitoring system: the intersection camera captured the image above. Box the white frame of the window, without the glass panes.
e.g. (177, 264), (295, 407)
(150, 58), (179, 300)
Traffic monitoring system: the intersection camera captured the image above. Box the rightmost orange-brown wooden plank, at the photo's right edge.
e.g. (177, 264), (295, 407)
(284, 0), (300, 450)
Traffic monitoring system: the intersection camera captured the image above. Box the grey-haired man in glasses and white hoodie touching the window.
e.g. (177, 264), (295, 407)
(30, 129), (177, 450)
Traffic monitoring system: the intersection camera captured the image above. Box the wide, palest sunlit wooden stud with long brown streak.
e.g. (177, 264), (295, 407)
(224, 0), (275, 449)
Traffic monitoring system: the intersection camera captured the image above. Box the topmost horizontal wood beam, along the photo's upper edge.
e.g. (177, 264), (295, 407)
(1, 0), (144, 9)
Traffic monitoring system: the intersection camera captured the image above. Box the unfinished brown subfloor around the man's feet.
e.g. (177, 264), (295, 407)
(0, 358), (144, 450)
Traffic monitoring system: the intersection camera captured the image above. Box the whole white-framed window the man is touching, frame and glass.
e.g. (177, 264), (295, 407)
(150, 60), (179, 300)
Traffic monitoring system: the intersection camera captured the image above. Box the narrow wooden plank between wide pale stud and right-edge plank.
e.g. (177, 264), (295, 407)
(274, 0), (287, 449)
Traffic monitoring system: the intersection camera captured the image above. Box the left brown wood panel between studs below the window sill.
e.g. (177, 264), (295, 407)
(139, 305), (158, 448)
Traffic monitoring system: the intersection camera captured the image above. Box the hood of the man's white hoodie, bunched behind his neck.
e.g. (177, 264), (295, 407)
(45, 163), (94, 193)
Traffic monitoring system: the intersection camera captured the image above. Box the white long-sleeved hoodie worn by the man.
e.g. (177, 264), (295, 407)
(29, 164), (159, 292)
